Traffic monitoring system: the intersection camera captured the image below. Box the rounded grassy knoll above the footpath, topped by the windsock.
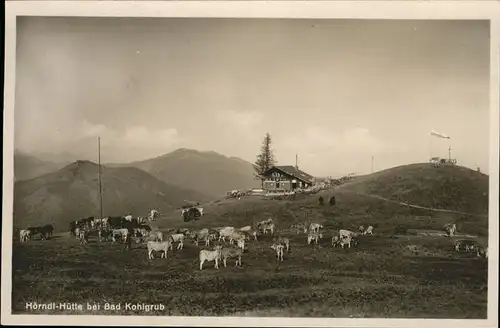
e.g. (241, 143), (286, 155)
(339, 163), (489, 214)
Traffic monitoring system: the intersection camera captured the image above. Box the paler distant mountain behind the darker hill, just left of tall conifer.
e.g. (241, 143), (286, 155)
(107, 148), (260, 198)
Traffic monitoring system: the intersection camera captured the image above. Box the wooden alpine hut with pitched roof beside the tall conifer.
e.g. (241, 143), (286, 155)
(263, 165), (314, 192)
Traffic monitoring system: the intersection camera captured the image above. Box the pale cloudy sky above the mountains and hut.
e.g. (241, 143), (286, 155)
(15, 17), (490, 176)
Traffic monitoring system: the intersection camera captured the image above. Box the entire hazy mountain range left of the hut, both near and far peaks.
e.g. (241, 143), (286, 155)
(14, 149), (260, 228)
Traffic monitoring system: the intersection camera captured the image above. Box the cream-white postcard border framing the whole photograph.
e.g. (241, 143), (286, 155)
(1, 1), (500, 328)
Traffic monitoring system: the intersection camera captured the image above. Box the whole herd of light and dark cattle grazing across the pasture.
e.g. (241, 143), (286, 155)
(16, 207), (488, 270)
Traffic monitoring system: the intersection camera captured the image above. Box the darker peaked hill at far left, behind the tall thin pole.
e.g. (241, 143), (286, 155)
(14, 161), (211, 231)
